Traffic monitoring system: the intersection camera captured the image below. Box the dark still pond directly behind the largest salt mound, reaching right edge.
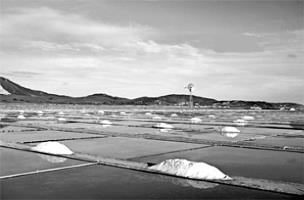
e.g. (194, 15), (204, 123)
(133, 147), (304, 183)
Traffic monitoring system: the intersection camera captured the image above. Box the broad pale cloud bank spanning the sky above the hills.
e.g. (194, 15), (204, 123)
(0, 8), (304, 101)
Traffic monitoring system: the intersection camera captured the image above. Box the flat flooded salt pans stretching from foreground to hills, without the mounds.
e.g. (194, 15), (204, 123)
(0, 104), (304, 199)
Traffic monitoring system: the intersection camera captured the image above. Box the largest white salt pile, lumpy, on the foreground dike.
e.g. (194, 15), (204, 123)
(149, 159), (232, 180)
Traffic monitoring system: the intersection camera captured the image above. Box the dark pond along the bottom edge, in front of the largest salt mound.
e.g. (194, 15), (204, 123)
(1, 165), (292, 199)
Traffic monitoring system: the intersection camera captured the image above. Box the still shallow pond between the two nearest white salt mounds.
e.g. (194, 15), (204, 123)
(61, 137), (207, 158)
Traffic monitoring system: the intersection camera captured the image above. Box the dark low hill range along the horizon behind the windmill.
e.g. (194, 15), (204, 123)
(0, 77), (304, 110)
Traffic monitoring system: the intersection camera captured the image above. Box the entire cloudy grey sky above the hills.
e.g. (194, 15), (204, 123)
(0, 0), (304, 104)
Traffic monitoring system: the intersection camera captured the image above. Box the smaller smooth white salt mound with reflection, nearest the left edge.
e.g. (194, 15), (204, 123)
(31, 142), (73, 155)
